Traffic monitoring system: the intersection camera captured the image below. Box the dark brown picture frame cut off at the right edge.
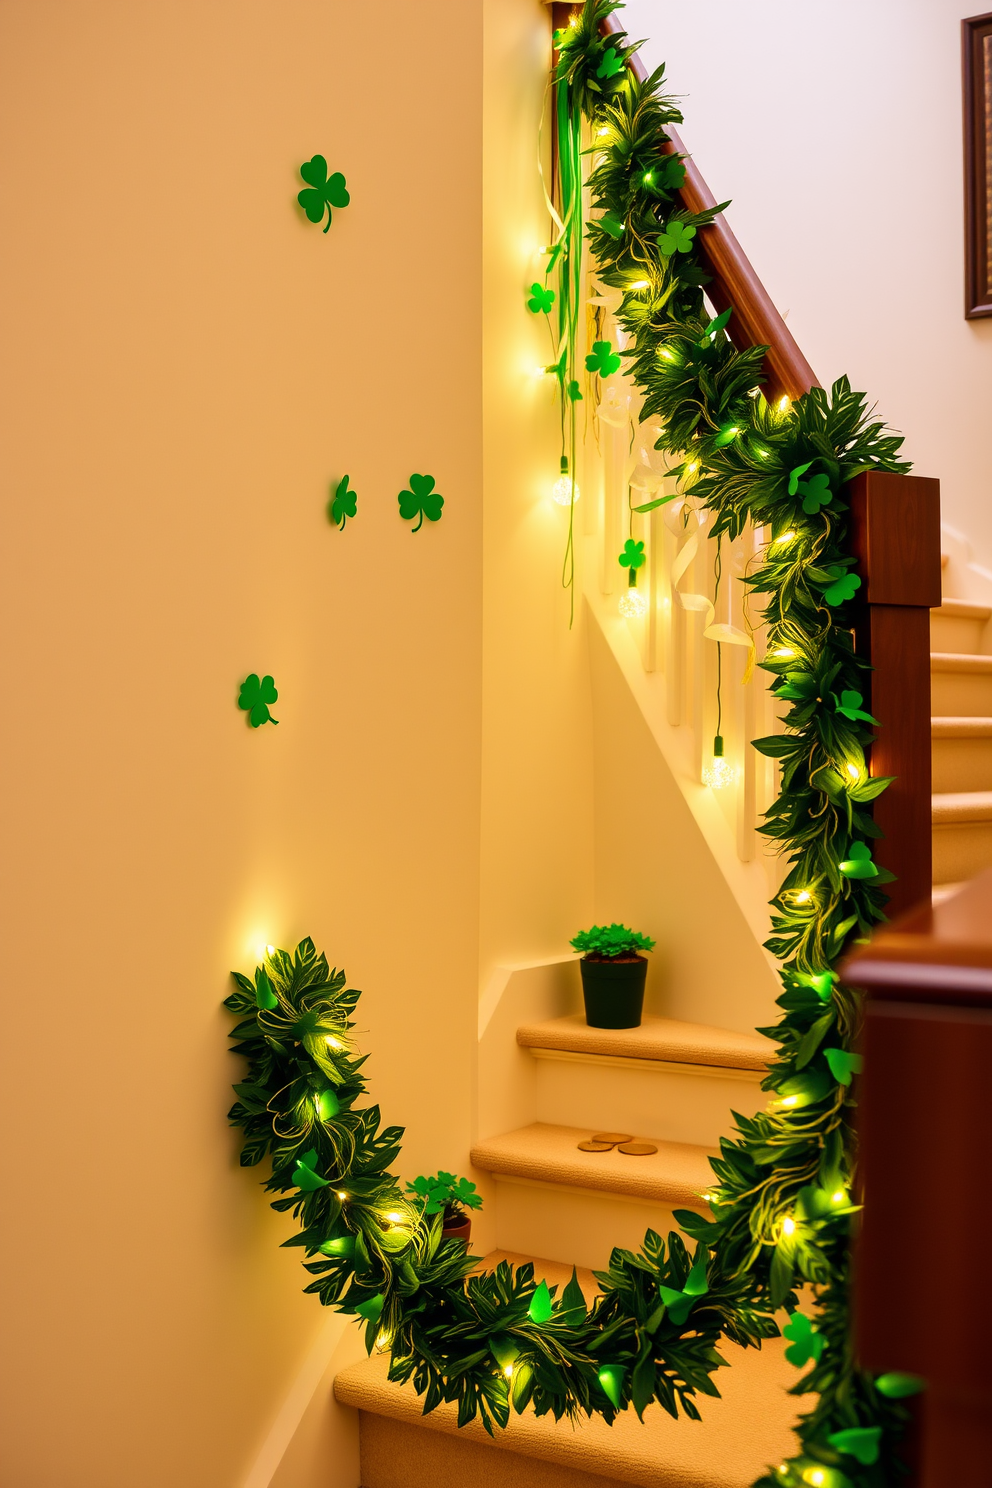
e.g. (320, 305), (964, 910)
(961, 10), (992, 320)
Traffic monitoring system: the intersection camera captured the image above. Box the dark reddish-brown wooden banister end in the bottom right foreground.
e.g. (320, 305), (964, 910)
(843, 870), (992, 1488)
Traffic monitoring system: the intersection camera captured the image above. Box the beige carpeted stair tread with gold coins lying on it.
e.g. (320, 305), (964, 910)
(471, 1122), (717, 1210)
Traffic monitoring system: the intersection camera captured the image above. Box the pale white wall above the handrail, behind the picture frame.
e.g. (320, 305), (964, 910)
(623, 0), (992, 565)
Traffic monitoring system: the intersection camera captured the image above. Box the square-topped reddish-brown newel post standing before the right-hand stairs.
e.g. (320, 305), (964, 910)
(848, 470), (940, 917)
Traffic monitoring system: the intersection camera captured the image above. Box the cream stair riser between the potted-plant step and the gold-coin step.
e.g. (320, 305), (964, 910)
(535, 1055), (769, 1142)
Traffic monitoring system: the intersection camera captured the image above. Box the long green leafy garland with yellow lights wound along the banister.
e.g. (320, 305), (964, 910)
(226, 0), (918, 1488)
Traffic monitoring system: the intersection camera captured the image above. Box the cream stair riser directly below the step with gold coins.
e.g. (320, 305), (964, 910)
(495, 1174), (701, 1271)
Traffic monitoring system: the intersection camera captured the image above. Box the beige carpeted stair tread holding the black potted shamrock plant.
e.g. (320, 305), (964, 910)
(516, 1013), (775, 1073)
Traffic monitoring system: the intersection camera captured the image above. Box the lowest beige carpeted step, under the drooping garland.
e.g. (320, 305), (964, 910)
(335, 1251), (799, 1488)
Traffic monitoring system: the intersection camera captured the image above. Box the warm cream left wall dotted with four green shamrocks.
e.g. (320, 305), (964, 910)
(0, 0), (482, 1488)
